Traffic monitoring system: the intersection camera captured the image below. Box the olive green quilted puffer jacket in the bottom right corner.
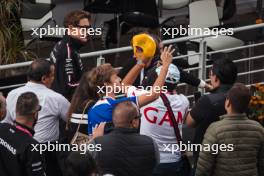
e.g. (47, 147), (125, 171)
(196, 114), (264, 176)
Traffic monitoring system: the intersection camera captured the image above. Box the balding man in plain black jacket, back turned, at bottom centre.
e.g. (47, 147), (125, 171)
(89, 101), (159, 176)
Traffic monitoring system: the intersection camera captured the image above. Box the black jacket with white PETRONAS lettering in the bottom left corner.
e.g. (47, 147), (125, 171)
(0, 123), (45, 176)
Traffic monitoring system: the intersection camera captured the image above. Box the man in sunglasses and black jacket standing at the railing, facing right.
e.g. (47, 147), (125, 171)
(50, 10), (93, 100)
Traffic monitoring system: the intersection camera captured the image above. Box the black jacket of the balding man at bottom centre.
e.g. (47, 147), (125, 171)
(92, 128), (159, 176)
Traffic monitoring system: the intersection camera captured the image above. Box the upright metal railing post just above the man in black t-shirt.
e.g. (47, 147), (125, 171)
(198, 38), (207, 94)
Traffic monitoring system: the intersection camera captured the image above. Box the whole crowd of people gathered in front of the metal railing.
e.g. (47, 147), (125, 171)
(0, 10), (264, 176)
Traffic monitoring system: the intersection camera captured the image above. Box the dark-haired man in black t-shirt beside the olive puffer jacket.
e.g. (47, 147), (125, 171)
(186, 58), (237, 175)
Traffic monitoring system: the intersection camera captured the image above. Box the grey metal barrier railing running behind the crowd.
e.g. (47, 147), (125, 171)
(0, 24), (264, 93)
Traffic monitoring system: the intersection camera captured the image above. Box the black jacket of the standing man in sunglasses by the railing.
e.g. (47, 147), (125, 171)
(50, 35), (83, 100)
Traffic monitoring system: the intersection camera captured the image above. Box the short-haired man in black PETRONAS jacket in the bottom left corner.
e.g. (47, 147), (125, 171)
(0, 92), (45, 176)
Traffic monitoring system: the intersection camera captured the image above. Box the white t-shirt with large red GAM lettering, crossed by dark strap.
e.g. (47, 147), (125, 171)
(127, 86), (189, 163)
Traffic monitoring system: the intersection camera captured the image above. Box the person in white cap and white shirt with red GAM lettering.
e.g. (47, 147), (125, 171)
(128, 64), (189, 176)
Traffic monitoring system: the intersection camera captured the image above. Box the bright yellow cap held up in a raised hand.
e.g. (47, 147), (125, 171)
(132, 34), (157, 59)
